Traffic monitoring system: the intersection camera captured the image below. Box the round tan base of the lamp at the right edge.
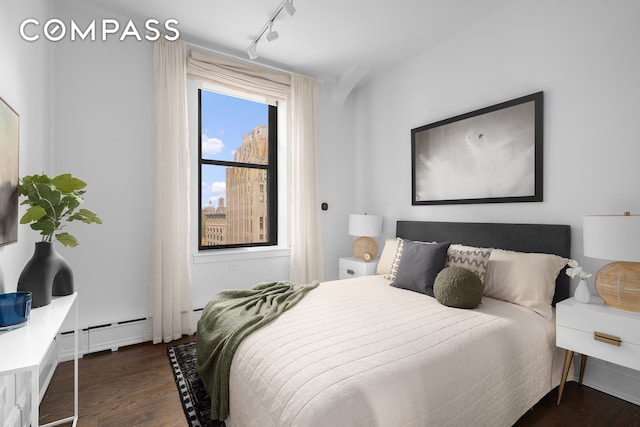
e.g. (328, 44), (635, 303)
(595, 261), (640, 312)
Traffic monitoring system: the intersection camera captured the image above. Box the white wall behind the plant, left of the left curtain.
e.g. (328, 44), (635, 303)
(53, 2), (154, 326)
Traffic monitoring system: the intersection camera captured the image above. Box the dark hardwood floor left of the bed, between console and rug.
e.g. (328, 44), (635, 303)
(40, 337), (194, 427)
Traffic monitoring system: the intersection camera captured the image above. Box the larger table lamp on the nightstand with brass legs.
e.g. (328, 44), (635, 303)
(583, 212), (640, 312)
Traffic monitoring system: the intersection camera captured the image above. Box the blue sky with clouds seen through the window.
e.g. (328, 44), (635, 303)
(201, 89), (269, 207)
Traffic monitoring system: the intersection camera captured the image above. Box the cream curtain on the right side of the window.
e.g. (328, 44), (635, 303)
(289, 74), (324, 283)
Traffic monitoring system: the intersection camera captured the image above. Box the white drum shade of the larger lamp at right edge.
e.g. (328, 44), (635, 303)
(582, 215), (640, 262)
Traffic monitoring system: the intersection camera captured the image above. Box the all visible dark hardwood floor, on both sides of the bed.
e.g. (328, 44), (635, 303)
(40, 337), (640, 427)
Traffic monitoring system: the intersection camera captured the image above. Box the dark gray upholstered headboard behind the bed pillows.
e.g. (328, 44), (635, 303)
(396, 221), (571, 305)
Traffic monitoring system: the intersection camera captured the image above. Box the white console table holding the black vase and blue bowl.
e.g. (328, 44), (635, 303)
(0, 293), (78, 427)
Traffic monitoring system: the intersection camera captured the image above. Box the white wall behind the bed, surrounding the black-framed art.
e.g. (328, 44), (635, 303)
(344, 0), (640, 401)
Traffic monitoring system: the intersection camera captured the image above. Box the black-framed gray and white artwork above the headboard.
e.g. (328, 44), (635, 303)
(411, 92), (543, 205)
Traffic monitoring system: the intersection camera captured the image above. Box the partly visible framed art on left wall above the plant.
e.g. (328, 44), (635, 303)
(0, 98), (20, 246)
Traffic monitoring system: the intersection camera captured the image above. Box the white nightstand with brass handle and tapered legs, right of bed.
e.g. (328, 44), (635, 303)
(556, 296), (640, 404)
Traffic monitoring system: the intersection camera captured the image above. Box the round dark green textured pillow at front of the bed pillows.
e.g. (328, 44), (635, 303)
(433, 267), (484, 308)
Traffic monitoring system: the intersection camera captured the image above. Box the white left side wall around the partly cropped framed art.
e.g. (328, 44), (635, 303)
(0, 0), (53, 426)
